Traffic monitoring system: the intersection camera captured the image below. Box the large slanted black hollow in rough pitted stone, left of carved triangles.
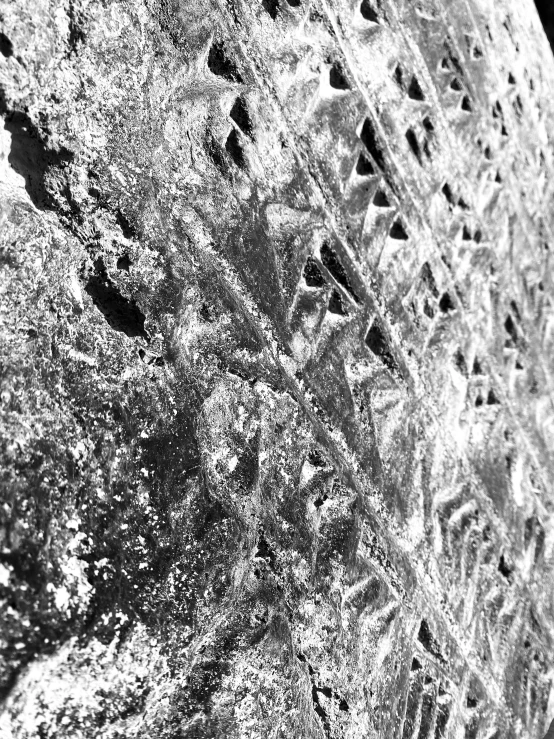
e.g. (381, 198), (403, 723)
(85, 259), (148, 339)
